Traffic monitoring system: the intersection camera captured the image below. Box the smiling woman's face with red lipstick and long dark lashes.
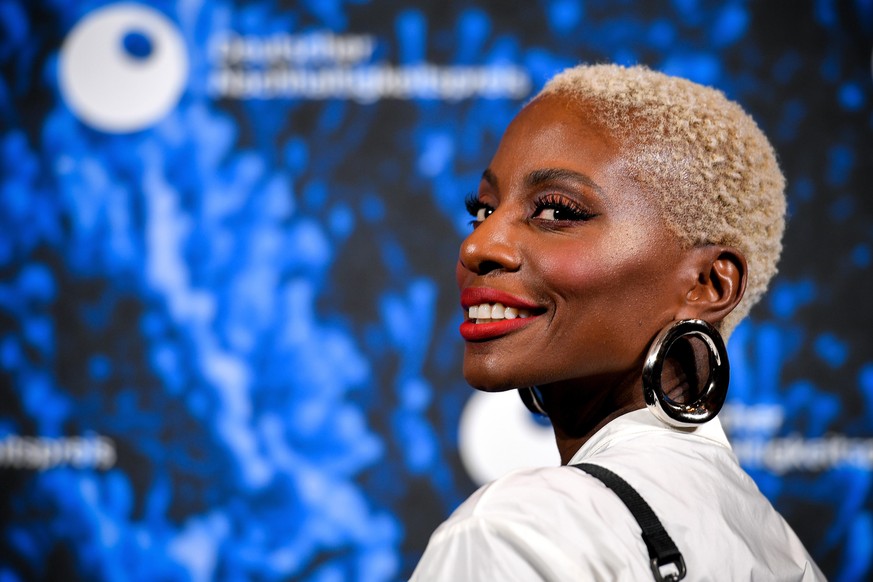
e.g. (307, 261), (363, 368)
(457, 95), (696, 390)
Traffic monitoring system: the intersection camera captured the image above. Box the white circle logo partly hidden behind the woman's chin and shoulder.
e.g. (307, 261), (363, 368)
(458, 390), (561, 485)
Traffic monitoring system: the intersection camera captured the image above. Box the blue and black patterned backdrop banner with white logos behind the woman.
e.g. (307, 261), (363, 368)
(0, 0), (873, 582)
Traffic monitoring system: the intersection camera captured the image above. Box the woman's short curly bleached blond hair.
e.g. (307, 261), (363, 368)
(535, 65), (786, 337)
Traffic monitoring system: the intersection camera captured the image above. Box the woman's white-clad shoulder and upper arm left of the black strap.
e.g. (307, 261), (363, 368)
(417, 467), (648, 580)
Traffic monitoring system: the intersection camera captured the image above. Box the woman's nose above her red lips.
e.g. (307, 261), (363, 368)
(459, 209), (521, 275)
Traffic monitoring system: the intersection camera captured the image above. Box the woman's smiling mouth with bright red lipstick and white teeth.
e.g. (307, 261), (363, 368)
(460, 287), (543, 341)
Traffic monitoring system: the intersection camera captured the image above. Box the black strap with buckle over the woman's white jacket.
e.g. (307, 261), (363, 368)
(571, 463), (685, 582)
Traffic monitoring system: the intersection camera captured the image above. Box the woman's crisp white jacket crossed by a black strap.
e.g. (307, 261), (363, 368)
(412, 410), (824, 582)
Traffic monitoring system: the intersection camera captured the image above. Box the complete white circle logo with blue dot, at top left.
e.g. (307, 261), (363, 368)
(58, 3), (188, 133)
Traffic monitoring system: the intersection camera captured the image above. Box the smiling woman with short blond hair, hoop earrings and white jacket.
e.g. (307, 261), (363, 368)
(413, 65), (823, 580)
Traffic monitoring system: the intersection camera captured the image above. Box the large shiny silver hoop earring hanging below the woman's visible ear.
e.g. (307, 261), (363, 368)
(643, 319), (730, 428)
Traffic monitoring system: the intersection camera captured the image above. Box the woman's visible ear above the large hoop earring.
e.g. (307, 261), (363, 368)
(677, 245), (747, 325)
